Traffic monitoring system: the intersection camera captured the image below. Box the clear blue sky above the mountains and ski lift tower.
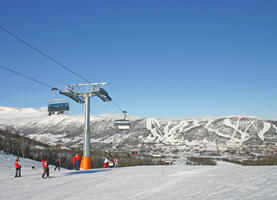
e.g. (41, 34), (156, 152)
(0, 0), (277, 118)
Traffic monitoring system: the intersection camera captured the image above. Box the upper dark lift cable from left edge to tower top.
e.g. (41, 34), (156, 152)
(0, 26), (89, 83)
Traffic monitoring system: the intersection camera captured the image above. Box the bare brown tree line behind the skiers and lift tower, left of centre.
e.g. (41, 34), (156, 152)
(0, 130), (167, 169)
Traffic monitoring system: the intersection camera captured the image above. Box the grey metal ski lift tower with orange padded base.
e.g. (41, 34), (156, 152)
(60, 83), (112, 169)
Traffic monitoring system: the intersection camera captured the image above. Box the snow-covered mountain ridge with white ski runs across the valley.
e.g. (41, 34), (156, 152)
(0, 107), (277, 156)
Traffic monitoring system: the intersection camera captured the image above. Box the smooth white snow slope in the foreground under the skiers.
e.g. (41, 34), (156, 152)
(0, 153), (277, 200)
